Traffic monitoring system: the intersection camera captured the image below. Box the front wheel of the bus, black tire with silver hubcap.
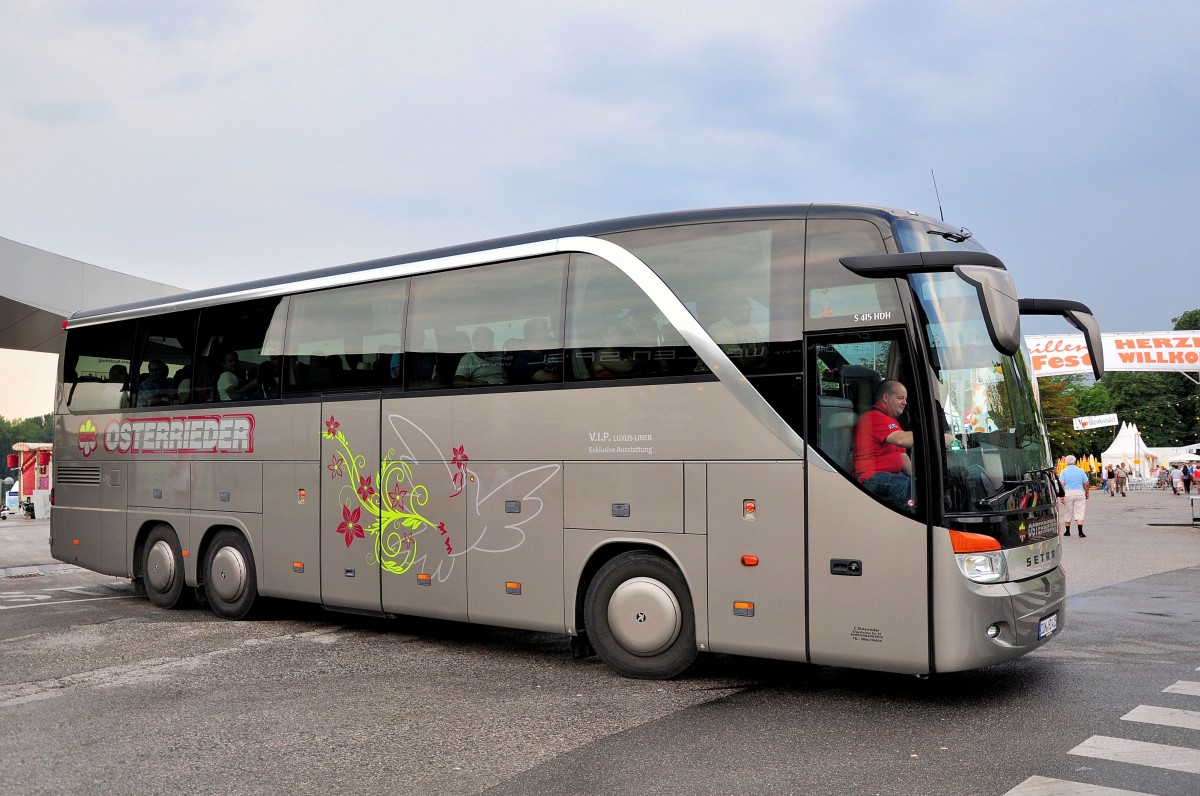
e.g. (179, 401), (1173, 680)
(583, 550), (697, 680)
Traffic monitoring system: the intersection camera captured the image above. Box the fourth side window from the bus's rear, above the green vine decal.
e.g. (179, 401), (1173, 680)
(283, 280), (408, 390)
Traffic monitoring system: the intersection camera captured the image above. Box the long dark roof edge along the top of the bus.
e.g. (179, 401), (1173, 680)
(67, 203), (926, 328)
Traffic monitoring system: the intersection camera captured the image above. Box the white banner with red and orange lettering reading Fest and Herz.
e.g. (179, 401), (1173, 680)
(1025, 331), (1200, 377)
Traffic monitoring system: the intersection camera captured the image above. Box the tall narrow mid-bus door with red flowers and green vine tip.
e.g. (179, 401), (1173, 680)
(320, 394), (382, 611)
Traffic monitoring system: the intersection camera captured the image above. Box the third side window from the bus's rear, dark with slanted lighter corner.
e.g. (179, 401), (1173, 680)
(199, 298), (287, 401)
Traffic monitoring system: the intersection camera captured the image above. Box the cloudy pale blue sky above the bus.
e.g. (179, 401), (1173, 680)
(0, 0), (1200, 417)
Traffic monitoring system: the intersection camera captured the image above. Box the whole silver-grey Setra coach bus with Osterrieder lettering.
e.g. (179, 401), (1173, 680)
(52, 204), (1102, 677)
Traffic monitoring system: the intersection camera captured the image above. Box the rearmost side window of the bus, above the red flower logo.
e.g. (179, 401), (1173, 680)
(62, 321), (136, 412)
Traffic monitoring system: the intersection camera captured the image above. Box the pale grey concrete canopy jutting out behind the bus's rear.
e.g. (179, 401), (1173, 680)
(0, 231), (184, 354)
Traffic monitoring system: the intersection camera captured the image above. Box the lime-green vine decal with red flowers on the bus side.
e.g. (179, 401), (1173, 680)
(322, 415), (458, 575)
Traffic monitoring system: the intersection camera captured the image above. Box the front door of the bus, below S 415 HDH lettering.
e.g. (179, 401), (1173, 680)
(805, 330), (931, 674)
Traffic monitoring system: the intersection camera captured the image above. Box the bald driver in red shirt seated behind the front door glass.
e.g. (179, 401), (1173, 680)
(854, 379), (913, 511)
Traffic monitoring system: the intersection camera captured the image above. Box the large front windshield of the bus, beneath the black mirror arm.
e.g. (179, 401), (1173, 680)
(908, 273), (1050, 514)
